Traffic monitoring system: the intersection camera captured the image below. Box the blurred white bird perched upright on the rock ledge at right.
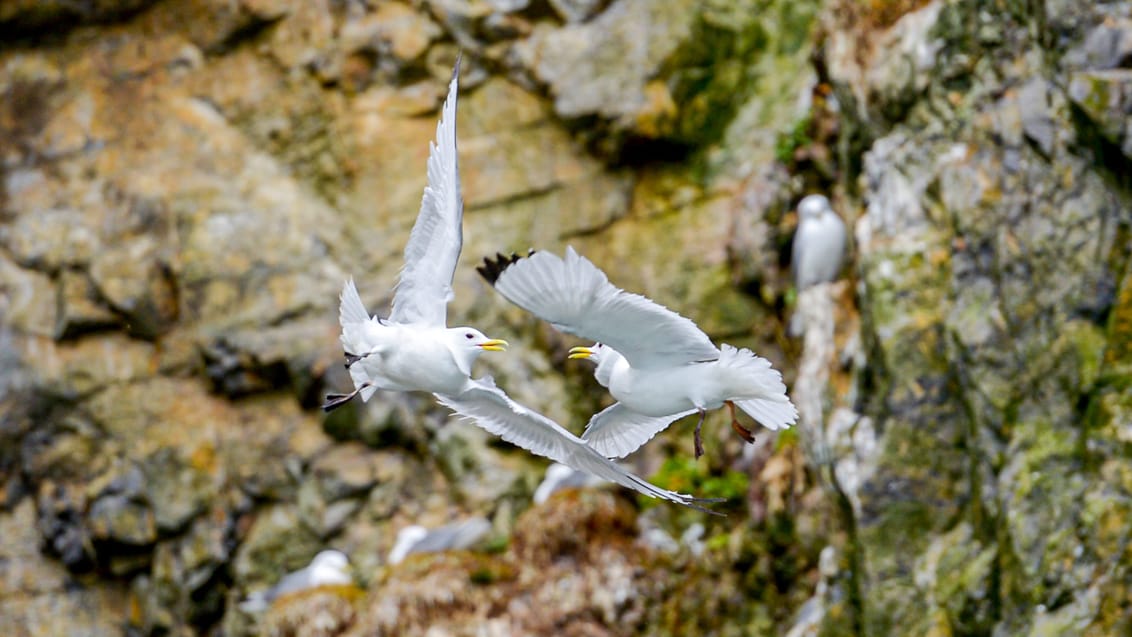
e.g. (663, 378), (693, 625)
(790, 195), (846, 292)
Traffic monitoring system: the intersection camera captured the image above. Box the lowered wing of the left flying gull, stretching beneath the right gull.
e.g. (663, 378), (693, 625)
(435, 378), (721, 515)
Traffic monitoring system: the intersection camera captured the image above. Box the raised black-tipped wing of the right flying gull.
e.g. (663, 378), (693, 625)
(477, 248), (719, 369)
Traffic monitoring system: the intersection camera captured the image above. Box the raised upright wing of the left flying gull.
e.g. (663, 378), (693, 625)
(389, 60), (464, 327)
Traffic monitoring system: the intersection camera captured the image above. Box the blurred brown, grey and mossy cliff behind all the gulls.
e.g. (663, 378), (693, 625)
(0, 0), (1132, 637)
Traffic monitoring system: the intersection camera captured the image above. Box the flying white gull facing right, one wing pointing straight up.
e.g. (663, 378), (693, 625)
(323, 61), (713, 510)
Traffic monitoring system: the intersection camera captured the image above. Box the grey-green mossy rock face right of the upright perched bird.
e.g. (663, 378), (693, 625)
(826, 0), (1132, 635)
